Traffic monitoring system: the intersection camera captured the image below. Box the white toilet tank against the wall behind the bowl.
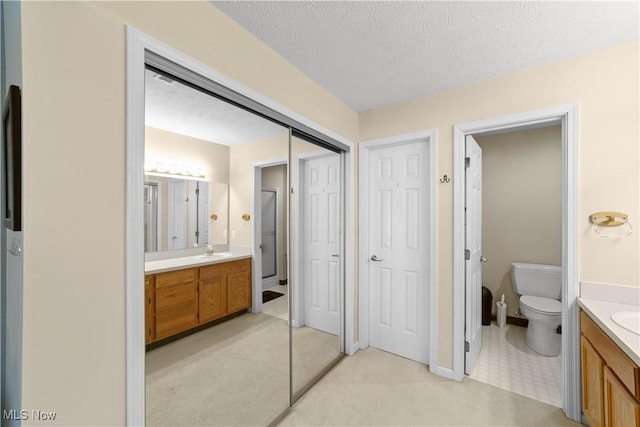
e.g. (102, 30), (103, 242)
(511, 262), (562, 300)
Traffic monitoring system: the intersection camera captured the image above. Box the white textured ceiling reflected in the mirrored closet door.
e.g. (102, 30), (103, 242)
(145, 70), (288, 145)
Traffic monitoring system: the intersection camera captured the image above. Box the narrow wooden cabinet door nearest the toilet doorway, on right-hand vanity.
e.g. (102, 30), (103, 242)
(580, 335), (604, 427)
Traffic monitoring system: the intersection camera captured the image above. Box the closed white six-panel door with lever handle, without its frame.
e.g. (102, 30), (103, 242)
(363, 142), (430, 363)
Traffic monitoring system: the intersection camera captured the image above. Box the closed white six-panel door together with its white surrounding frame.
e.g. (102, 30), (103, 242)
(360, 131), (436, 370)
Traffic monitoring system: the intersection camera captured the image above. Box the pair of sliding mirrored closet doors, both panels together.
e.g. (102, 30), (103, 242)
(144, 56), (344, 425)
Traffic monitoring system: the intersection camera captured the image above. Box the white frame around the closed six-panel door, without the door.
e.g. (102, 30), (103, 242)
(358, 129), (442, 375)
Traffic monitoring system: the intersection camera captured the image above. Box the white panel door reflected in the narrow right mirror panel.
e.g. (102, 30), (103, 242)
(302, 154), (341, 335)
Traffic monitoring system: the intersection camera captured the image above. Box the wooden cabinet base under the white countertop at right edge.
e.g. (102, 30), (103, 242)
(580, 312), (640, 427)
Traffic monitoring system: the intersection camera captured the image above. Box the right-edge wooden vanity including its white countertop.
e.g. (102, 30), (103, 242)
(579, 299), (640, 427)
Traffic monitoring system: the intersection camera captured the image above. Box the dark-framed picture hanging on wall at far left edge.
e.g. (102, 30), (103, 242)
(2, 85), (22, 231)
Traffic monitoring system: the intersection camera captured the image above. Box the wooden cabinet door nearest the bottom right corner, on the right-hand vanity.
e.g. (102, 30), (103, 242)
(604, 366), (640, 427)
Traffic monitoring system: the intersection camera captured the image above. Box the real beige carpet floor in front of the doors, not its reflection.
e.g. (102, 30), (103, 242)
(280, 348), (580, 426)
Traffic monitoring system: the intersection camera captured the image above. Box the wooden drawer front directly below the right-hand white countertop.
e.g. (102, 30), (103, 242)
(580, 311), (640, 399)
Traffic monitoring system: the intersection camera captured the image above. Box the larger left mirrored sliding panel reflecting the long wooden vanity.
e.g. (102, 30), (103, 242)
(145, 67), (290, 426)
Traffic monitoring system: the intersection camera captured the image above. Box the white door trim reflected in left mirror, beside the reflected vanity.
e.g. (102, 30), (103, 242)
(251, 157), (289, 313)
